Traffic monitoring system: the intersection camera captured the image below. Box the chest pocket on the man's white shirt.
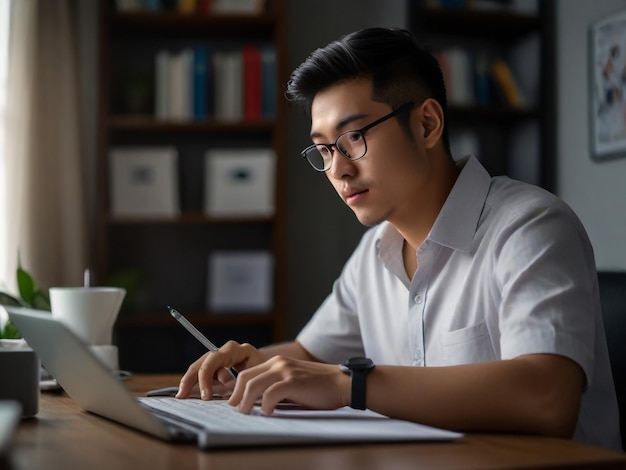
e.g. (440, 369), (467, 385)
(441, 322), (497, 366)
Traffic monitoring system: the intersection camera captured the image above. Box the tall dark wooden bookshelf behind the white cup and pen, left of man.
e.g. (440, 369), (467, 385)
(93, 0), (287, 372)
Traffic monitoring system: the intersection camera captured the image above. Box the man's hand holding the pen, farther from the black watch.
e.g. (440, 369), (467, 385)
(176, 341), (267, 400)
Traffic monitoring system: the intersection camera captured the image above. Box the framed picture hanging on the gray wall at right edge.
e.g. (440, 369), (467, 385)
(589, 11), (626, 160)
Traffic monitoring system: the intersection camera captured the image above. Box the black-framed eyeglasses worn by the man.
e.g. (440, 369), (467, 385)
(300, 101), (415, 171)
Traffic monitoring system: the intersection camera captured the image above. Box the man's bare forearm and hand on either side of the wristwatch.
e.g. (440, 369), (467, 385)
(230, 354), (584, 437)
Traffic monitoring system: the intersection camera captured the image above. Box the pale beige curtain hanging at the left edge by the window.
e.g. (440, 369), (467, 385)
(0, 0), (87, 292)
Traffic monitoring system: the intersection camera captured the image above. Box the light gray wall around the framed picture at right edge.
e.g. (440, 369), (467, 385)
(556, 0), (626, 270)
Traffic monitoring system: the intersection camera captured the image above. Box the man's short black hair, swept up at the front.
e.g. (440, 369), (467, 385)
(285, 28), (450, 153)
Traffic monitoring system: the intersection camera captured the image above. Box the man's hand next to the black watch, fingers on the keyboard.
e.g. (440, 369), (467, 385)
(228, 356), (351, 414)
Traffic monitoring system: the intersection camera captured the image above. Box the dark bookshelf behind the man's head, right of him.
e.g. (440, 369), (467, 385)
(408, 0), (555, 190)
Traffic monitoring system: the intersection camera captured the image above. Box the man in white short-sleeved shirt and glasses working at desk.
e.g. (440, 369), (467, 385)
(178, 28), (620, 448)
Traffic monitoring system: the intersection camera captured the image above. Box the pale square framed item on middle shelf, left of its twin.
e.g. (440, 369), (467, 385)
(109, 147), (180, 217)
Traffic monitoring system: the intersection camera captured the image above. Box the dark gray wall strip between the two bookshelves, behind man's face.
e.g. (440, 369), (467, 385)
(287, 0), (408, 336)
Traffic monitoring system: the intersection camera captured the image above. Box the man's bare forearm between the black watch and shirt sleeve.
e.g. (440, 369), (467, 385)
(367, 354), (584, 437)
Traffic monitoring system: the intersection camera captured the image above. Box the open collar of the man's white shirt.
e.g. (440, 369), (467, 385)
(376, 156), (491, 260)
